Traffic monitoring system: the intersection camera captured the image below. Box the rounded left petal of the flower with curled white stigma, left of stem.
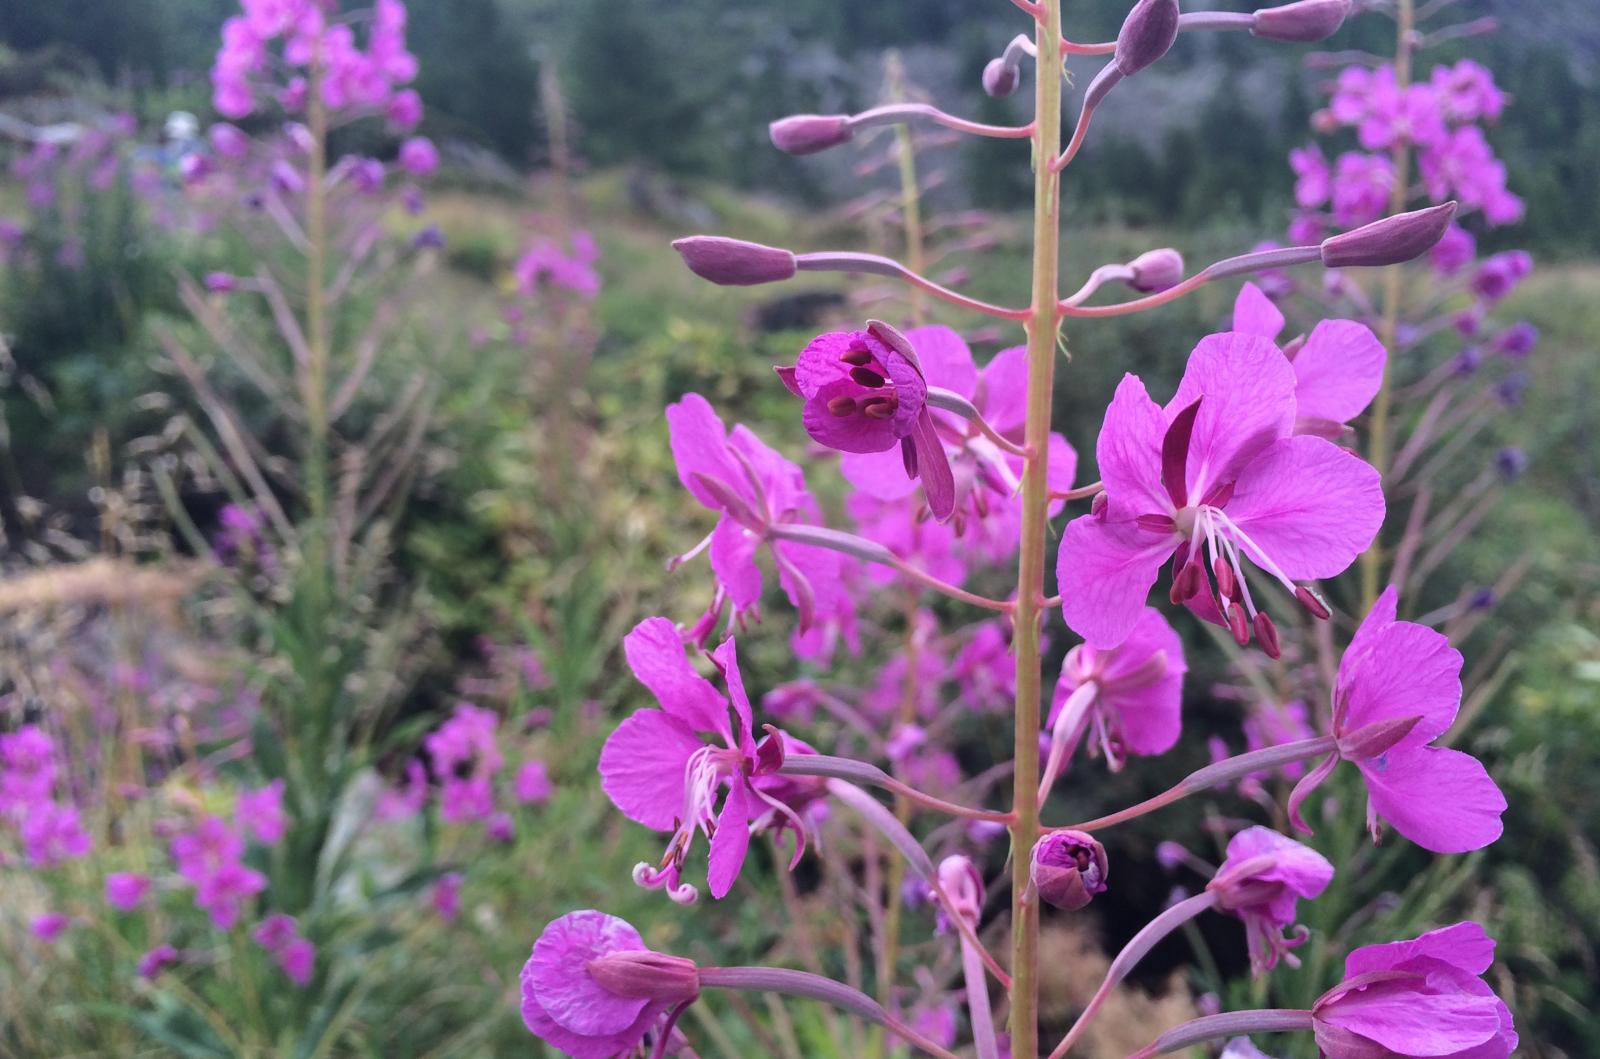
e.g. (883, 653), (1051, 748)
(600, 710), (704, 830)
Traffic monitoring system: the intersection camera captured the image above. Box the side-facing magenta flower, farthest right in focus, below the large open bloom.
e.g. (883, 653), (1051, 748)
(1290, 585), (1506, 853)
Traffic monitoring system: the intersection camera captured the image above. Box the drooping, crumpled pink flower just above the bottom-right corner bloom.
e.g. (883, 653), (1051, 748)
(1206, 827), (1333, 974)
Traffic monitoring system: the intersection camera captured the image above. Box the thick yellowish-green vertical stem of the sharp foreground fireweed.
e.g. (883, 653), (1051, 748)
(1011, 0), (1062, 1059)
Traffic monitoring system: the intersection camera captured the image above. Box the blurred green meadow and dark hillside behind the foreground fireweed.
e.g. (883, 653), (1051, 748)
(0, 0), (1600, 1059)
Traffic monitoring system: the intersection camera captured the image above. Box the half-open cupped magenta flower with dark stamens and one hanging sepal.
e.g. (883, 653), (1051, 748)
(779, 320), (955, 522)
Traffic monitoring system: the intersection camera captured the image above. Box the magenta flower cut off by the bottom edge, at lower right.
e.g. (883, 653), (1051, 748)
(1312, 923), (1517, 1059)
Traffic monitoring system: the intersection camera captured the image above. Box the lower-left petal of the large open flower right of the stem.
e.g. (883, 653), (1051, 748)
(1056, 518), (1174, 649)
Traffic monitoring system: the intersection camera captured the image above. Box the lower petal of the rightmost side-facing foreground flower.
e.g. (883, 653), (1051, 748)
(1357, 747), (1506, 853)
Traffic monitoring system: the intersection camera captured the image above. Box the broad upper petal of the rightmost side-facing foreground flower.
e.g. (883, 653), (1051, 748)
(1344, 621), (1461, 750)
